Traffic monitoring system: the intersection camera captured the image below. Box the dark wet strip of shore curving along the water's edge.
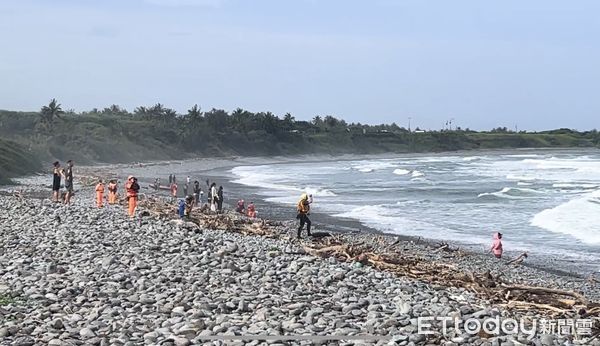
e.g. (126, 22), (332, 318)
(10, 148), (596, 278)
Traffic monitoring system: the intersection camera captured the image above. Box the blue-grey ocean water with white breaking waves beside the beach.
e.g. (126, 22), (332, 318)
(230, 150), (600, 271)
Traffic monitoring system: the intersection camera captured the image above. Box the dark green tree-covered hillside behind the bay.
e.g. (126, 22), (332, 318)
(0, 100), (600, 179)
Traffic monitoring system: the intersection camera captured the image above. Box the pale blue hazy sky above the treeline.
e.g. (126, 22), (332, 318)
(0, 0), (600, 129)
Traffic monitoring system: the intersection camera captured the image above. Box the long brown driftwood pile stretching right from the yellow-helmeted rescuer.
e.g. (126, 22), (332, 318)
(304, 236), (600, 318)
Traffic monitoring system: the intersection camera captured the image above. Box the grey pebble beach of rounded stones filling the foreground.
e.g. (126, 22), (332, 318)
(0, 176), (600, 346)
